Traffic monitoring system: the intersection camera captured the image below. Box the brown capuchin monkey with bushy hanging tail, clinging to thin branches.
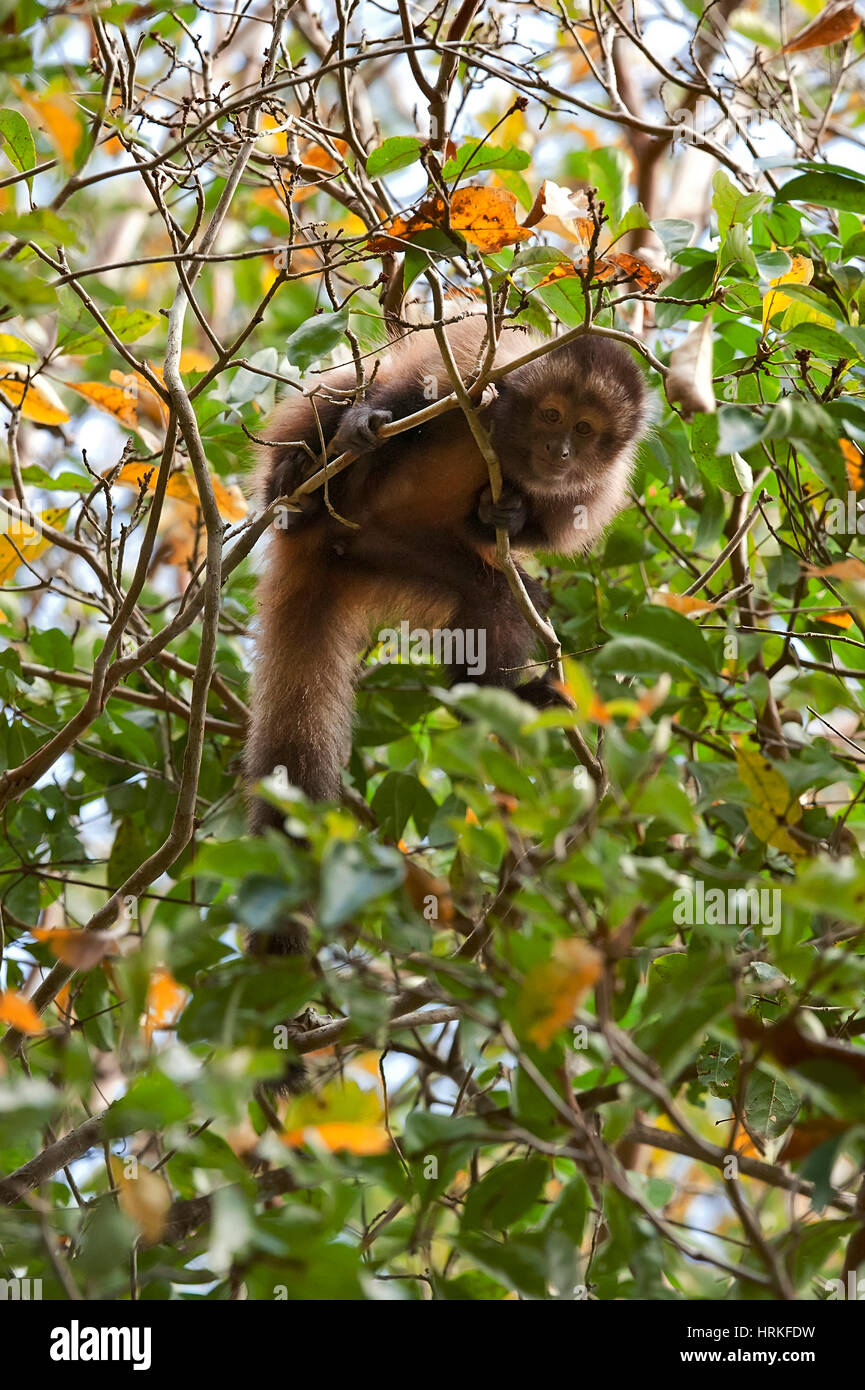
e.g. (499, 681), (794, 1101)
(245, 317), (648, 954)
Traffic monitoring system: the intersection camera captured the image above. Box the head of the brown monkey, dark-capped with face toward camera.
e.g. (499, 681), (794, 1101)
(490, 335), (647, 495)
